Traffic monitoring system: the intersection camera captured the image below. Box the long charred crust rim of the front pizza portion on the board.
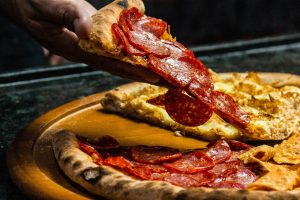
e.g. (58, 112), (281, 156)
(52, 130), (300, 200)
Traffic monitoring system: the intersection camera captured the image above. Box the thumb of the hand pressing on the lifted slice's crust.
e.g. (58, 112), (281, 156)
(35, 0), (97, 38)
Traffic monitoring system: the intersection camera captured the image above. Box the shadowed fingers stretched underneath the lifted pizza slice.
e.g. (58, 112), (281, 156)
(32, 21), (160, 83)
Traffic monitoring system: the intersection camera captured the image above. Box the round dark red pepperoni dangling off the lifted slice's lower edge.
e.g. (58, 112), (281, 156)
(165, 89), (212, 126)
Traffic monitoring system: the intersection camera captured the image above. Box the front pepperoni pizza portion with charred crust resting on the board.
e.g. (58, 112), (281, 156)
(52, 131), (300, 200)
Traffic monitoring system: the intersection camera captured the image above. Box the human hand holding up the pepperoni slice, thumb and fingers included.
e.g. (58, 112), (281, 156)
(4, 0), (159, 83)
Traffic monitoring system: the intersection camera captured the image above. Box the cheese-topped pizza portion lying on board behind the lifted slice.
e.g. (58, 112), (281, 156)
(101, 71), (300, 140)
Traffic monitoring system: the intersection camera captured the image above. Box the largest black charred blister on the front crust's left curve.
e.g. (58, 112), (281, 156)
(80, 167), (111, 185)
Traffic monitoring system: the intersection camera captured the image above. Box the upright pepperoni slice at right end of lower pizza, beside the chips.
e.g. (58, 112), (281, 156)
(202, 140), (231, 164)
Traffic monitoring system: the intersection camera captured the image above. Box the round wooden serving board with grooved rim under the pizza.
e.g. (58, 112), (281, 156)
(7, 74), (299, 199)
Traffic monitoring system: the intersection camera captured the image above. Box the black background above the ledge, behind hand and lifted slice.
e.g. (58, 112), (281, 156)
(0, 0), (300, 72)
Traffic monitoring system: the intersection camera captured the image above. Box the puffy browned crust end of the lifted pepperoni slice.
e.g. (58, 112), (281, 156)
(79, 0), (147, 67)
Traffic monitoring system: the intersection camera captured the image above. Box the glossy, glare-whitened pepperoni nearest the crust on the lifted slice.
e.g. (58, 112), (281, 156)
(127, 31), (170, 58)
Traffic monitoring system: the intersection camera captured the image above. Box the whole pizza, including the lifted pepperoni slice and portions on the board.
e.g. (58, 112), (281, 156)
(52, 0), (300, 200)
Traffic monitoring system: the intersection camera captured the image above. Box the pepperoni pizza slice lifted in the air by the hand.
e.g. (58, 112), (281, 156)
(79, 0), (250, 131)
